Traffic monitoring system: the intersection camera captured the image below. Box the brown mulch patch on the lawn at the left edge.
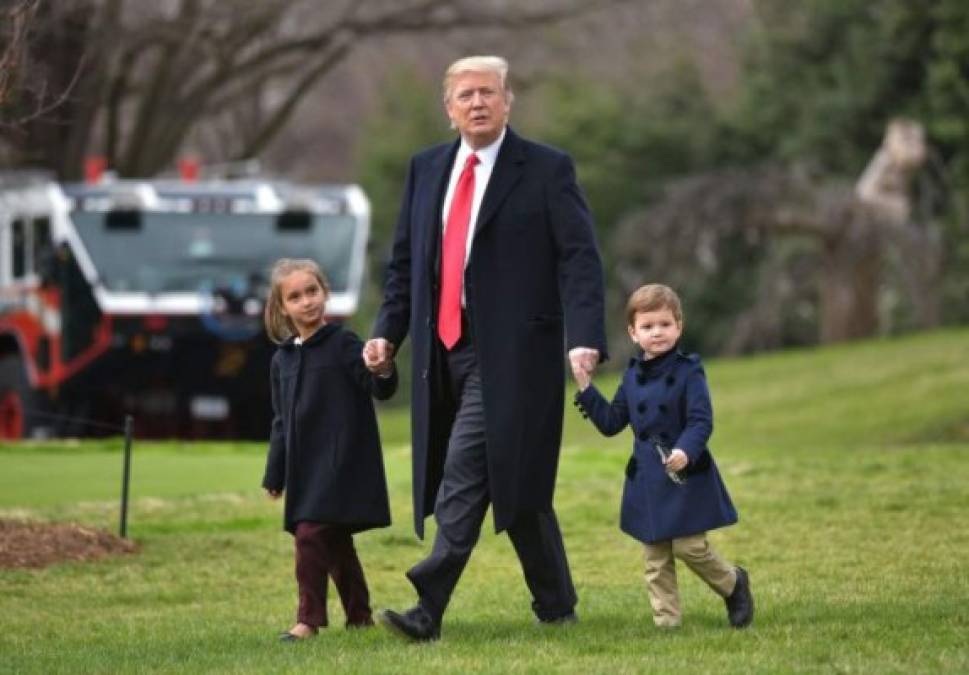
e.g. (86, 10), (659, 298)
(0, 519), (138, 567)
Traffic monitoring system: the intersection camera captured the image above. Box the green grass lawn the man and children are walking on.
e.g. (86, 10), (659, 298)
(0, 330), (969, 673)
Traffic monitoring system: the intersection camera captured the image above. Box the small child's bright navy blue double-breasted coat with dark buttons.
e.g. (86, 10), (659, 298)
(576, 350), (737, 543)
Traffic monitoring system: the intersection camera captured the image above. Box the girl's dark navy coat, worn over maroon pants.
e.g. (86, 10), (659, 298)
(262, 324), (397, 533)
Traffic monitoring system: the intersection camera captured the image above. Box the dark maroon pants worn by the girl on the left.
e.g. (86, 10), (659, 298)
(296, 520), (373, 627)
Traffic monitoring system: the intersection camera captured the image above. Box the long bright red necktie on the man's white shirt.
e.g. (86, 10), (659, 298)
(437, 154), (478, 349)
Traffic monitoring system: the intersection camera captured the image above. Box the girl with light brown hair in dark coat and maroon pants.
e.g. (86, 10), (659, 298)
(262, 259), (397, 641)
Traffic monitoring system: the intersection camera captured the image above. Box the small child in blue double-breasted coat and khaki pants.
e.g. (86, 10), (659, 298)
(573, 284), (754, 628)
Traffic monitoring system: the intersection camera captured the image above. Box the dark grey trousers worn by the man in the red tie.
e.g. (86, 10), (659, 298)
(407, 340), (577, 622)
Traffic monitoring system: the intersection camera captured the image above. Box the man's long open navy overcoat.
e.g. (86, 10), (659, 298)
(373, 128), (606, 537)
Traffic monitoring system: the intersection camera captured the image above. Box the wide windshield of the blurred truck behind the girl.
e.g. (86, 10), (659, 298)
(72, 211), (357, 293)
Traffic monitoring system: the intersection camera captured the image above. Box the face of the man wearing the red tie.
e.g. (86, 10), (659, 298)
(444, 72), (511, 149)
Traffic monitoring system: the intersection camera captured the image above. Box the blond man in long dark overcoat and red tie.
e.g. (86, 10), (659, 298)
(365, 57), (606, 640)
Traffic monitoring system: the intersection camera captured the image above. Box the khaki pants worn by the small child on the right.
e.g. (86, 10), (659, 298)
(644, 532), (737, 627)
